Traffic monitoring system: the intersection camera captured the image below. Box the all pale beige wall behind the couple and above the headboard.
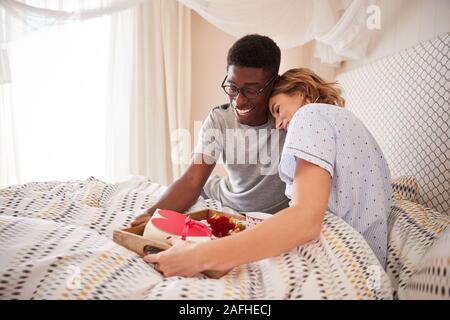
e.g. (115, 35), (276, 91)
(190, 0), (450, 175)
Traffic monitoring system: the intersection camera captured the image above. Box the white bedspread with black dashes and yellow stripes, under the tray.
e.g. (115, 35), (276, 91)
(0, 177), (392, 299)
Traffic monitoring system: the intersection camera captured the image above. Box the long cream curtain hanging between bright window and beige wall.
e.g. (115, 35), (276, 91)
(107, 0), (191, 184)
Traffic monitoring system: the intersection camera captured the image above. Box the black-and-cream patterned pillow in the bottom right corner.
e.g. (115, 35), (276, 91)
(398, 228), (450, 300)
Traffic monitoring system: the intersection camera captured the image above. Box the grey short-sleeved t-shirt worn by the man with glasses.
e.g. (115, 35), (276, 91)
(193, 104), (289, 213)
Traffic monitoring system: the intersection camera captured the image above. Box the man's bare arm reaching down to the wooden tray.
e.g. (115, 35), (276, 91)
(131, 154), (216, 227)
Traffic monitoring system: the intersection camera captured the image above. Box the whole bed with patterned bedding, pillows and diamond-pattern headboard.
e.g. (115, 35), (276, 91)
(0, 35), (450, 300)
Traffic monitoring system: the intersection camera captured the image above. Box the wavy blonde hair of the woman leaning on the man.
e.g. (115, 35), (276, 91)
(271, 68), (345, 107)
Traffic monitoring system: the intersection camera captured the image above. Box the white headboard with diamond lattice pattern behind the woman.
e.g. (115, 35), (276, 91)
(337, 33), (450, 214)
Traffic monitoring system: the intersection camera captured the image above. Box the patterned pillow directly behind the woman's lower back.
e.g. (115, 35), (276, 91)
(386, 198), (450, 298)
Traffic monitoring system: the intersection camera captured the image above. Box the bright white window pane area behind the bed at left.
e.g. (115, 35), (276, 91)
(10, 17), (110, 183)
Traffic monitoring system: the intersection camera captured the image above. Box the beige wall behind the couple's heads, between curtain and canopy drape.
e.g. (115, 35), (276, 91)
(190, 11), (335, 175)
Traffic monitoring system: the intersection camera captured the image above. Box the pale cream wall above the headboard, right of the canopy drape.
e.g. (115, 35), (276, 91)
(338, 0), (450, 73)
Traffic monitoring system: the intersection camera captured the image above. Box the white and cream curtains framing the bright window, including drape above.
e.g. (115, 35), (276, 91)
(0, 0), (191, 185)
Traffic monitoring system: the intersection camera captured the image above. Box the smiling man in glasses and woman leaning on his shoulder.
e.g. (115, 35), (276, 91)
(133, 35), (391, 276)
